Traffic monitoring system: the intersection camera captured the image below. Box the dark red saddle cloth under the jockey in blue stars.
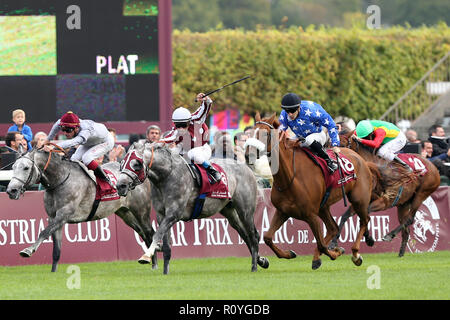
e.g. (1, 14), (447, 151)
(303, 148), (356, 189)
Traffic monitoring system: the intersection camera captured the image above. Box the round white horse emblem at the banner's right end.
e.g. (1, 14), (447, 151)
(408, 197), (441, 253)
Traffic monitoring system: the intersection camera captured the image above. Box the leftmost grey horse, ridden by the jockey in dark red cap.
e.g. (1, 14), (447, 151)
(6, 150), (157, 272)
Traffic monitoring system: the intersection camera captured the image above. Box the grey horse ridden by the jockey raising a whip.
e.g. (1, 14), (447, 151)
(117, 142), (269, 274)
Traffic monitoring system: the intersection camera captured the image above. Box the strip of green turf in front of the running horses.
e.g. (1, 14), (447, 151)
(0, 251), (450, 300)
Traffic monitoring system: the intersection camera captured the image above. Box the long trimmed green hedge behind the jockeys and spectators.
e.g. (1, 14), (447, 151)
(173, 24), (450, 120)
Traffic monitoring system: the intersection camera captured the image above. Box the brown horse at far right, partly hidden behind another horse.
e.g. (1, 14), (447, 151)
(330, 126), (440, 257)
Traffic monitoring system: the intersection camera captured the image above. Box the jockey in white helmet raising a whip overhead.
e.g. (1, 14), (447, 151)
(160, 93), (222, 184)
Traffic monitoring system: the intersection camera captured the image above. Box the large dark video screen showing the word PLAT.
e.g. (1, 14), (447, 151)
(0, 0), (159, 123)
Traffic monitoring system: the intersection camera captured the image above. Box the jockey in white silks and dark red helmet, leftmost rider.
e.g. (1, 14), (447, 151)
(47, 111), (115, 188)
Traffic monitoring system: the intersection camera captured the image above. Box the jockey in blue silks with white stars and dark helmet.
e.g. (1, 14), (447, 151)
(279, 93), (340, 173)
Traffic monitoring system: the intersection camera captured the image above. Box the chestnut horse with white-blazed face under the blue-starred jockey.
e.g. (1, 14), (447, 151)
(247, 113), (372, 270)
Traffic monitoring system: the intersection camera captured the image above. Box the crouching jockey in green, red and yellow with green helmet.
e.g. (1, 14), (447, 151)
(355, 120), (412, 171)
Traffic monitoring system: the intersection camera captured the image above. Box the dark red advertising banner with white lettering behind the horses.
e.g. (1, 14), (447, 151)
(0, 187), (450, 266)
